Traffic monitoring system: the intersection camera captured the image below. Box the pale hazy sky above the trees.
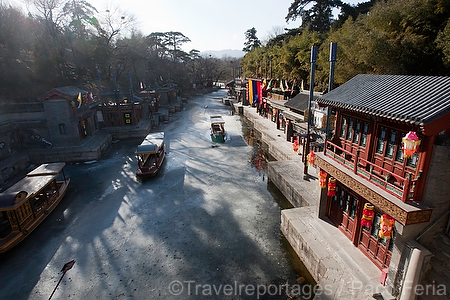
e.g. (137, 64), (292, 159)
(12, 0), (363, 51)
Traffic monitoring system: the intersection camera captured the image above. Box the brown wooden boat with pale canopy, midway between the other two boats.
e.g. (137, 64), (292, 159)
(134, 132), (166, 178)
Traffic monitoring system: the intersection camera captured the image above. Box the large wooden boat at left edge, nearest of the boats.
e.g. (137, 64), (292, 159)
(0, 163), (70, 253)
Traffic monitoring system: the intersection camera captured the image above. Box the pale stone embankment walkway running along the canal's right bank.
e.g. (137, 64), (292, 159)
(230, 101), (392, 300)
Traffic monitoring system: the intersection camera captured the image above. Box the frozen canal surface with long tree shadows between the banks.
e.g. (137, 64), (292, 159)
(0, 90), (304, 300)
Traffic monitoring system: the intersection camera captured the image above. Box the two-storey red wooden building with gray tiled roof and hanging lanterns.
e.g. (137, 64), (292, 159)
(315, 75), (450, 299)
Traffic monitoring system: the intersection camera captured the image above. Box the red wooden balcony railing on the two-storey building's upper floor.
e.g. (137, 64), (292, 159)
(324, 140), (419, 202)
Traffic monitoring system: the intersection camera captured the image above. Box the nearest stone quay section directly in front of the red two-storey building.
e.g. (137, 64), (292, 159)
(282, 206), (393, 300)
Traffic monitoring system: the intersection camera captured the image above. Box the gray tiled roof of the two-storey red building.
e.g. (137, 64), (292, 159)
(317, 74), (450, 126)
